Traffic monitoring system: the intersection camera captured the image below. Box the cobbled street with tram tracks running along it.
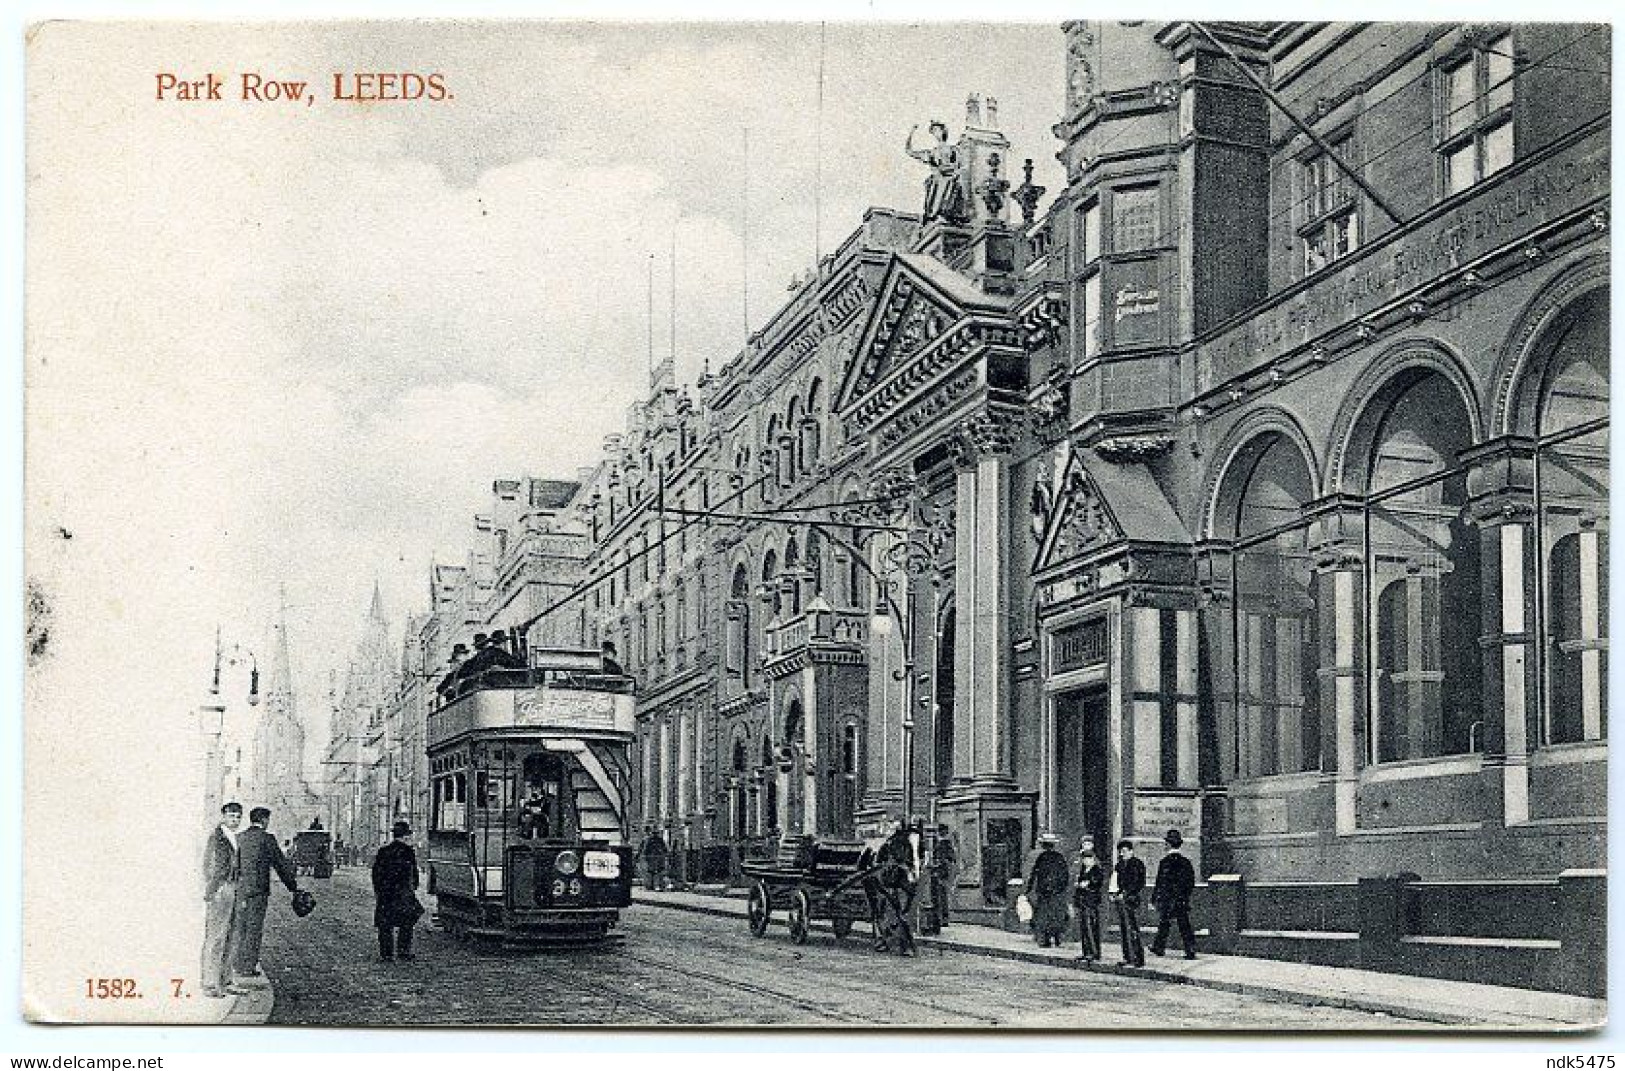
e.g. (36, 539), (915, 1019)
(263, 869), (1443, 1030)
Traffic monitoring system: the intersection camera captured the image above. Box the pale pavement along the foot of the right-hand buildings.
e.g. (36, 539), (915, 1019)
(634, 889), (1607, 1032)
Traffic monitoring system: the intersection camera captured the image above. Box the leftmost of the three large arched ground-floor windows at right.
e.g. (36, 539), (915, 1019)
(1219, 432), (1321, 777)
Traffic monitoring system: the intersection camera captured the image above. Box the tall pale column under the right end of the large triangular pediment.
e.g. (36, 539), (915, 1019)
(954, 413), (1014, 780)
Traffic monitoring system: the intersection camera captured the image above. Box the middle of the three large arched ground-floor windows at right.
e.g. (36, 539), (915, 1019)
(1365, 372), (1484, 762)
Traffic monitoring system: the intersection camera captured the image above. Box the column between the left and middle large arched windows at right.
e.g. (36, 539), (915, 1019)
(1305, 496), (1367, 837)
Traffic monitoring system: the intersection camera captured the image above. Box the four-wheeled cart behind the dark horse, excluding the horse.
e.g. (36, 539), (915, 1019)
(739, 837), (874, 944)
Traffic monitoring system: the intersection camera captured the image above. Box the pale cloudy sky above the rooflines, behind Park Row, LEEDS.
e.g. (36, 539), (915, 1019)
(26, 23), (1063, 864)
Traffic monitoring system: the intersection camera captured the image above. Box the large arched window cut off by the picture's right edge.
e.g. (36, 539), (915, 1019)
(1536, 293), (1609, 744)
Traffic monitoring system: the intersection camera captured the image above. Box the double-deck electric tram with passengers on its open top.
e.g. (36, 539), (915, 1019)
(427, 650), (634, 946)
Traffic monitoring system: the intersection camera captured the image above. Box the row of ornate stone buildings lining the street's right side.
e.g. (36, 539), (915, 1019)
(372, 23), (1609, 918)
